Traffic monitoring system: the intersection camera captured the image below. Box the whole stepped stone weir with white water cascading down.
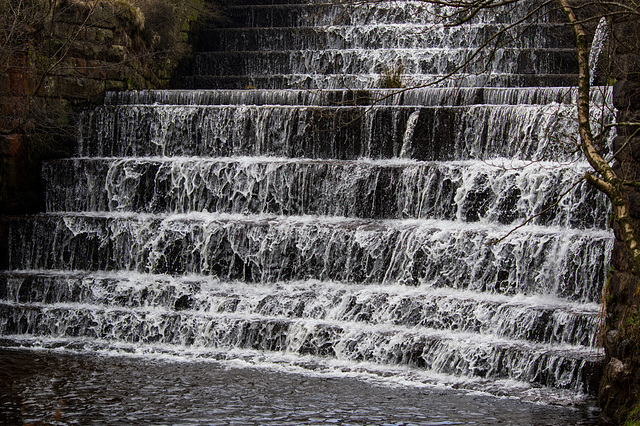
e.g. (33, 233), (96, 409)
(0, 0), (613, 416)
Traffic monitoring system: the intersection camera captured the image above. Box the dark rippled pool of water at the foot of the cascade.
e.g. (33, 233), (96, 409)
(0, 349), (598, 425)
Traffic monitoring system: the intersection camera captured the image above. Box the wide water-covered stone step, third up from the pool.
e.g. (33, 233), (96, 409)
(2, 213), (611, 302)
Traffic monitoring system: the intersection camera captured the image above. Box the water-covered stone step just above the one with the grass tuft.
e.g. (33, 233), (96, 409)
(193, 48), (578, 78)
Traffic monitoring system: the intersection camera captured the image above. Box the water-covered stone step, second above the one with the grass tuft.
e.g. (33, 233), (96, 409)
(199, 24), (575, 52)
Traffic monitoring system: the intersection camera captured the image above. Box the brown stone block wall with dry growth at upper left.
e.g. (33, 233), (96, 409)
(0, 0), (200, 214)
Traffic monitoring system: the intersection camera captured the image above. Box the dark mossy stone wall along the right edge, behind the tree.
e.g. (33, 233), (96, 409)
(599, 21), (640, 424)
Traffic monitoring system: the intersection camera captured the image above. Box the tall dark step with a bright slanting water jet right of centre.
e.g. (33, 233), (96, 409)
(78, 104), (596, 161)
